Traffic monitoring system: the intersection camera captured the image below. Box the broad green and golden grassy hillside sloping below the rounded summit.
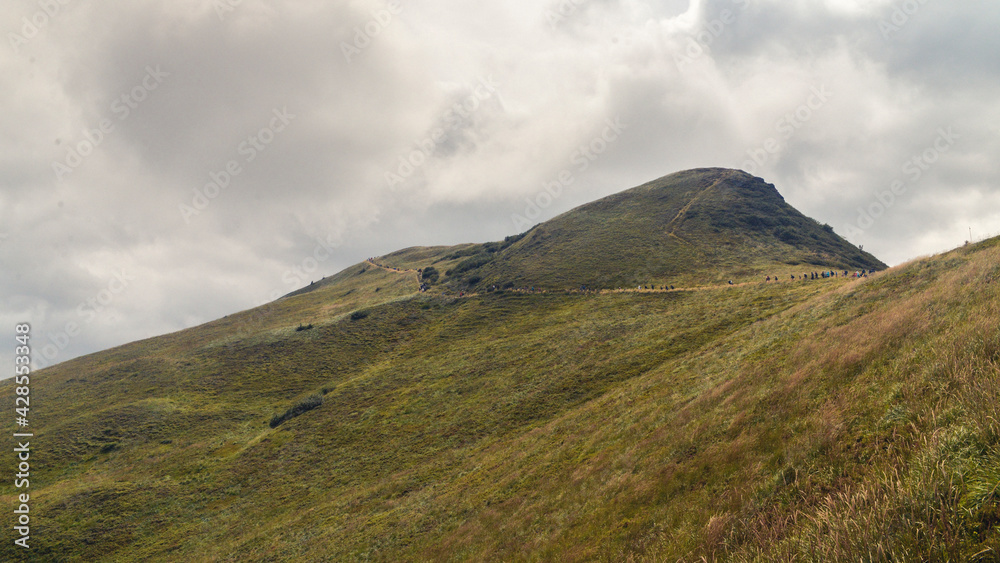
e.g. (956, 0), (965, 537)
(7, 171), (1000, 561)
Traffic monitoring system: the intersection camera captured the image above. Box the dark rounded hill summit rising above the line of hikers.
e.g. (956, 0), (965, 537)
(386, 168), (886, 289)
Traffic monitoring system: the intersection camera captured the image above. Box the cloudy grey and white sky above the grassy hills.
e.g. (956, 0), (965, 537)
(0, 0), (1000, 377)
